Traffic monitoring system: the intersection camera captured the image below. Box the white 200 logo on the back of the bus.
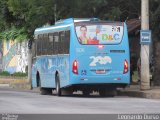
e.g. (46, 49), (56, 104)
(89, 56), (112, 66)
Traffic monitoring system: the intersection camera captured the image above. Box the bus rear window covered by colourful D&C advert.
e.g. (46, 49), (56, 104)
(75, 23), (123, 44)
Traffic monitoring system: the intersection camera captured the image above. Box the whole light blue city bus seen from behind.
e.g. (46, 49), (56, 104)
(32, 18), (130, 96)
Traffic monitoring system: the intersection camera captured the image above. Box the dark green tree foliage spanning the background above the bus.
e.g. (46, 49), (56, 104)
(0, 0), (160, 41)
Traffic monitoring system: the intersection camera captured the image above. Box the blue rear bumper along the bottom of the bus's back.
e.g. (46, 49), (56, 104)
(61, 74), (130, 88)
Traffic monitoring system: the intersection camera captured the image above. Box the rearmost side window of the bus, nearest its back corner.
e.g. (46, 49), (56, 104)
(64, 30), (70, 54)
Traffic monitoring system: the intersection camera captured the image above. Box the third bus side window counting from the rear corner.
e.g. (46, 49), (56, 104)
(53, 32), (59, 54)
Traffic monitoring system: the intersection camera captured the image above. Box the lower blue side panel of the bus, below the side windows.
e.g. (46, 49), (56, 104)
(32, 55), (69, 88)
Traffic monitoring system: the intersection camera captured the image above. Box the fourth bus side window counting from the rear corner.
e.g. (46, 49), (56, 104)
(48, 34), (54, 55)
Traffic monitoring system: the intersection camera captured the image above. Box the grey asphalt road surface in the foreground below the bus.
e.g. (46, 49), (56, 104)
(0, 89), (160, 114)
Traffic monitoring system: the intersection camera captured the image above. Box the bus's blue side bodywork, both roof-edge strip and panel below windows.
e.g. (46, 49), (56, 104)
(32, 19), (73, 88)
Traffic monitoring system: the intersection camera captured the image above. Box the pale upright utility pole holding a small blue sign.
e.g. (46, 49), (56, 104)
(140, 0), (150, 90)
